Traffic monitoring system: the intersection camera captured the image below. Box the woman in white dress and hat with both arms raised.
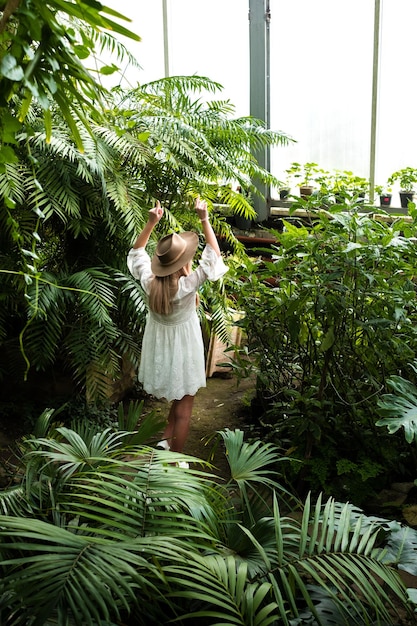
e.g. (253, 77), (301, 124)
(127, 198), (227, 452)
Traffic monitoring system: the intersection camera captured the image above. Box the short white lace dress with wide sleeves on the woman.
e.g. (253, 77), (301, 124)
(127, 245), (227, 400)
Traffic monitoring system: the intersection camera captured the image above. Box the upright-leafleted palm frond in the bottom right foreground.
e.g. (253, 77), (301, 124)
(270, 498), (408, 624)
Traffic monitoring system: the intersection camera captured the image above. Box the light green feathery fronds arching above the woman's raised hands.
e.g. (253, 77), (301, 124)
(115, 76), (291, 219)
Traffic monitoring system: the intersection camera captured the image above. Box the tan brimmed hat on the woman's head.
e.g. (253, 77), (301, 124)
(151, 232), (198, 276)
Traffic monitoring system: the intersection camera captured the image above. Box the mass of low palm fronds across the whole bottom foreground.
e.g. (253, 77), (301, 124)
(0, 411), (416, 626)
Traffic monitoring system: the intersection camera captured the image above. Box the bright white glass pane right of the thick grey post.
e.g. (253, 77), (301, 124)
(271, 0), (374, 188)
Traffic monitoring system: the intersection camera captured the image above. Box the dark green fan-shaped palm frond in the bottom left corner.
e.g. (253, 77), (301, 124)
(0, 516), (159, 626)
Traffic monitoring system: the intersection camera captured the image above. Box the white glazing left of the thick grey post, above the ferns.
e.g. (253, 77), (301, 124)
(109, 0), (249, 116)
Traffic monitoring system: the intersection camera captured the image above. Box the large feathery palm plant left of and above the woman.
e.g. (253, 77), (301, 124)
(0, 72), (292, 401)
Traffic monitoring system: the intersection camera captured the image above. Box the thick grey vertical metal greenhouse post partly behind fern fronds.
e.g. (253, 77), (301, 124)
(249, 0), (271, 222)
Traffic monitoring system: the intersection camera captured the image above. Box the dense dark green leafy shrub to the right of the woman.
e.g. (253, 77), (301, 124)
(231, 198), (417, 503)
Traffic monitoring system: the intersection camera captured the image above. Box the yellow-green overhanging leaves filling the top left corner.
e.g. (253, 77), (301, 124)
(0, 0), (140, 154)
